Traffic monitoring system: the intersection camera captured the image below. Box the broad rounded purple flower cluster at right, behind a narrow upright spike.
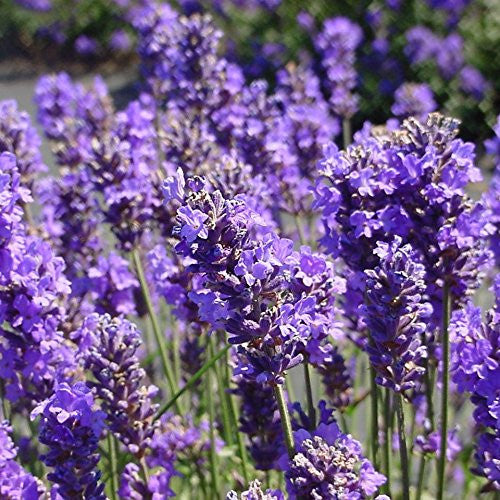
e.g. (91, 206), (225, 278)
(315, 113), (492, 332)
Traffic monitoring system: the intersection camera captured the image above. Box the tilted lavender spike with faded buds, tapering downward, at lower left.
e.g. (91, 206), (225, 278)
(73, 314), (158, 459)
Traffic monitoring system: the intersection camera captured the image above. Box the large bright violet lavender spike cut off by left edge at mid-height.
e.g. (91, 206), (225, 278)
(0, 153), (74, 410)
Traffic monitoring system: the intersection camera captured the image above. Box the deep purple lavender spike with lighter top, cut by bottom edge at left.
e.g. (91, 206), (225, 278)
(31, 382), (106, 500)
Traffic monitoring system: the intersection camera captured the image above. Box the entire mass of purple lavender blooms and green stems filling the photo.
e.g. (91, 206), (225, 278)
(0, 2), (500, 500)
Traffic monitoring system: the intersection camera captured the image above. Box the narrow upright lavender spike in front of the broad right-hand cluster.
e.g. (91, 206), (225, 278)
(361, 237), (431, 392)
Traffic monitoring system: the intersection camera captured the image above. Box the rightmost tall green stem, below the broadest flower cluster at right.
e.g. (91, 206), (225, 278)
(437, 283), (451, 500)
